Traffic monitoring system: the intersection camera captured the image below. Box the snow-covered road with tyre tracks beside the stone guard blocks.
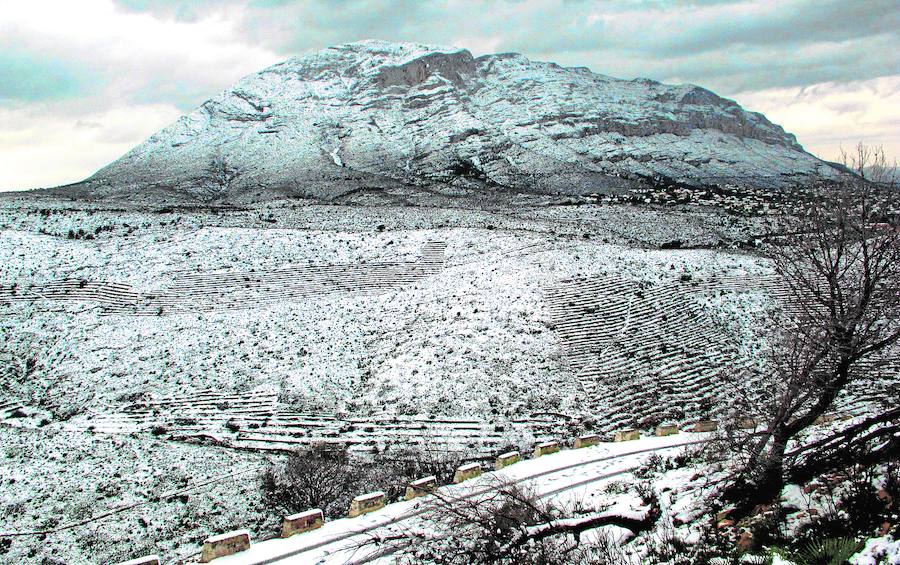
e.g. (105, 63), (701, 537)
(193, 434), (707, 565)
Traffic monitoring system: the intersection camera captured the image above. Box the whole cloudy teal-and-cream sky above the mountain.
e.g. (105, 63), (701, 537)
(0, 0), (900, 190)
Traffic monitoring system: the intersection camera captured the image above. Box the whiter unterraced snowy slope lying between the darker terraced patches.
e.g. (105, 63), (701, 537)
(0, 200), (816, 439)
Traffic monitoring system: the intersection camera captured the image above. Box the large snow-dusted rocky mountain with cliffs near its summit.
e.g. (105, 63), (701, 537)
(81, 41), (832, 200)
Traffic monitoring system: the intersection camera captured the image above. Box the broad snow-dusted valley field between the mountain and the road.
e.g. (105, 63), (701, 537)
(0, 196), (892, 563)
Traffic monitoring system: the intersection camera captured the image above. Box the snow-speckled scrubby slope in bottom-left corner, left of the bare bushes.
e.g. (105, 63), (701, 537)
(0, 426), (277, 563)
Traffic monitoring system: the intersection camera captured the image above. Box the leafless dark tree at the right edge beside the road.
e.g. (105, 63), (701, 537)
(729, 145), (900, 504)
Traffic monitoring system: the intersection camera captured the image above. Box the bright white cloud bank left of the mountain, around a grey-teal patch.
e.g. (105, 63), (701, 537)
(0, 0), (283, 190)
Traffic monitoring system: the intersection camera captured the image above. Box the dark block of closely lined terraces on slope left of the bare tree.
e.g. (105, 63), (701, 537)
(547, 276), (749, 429)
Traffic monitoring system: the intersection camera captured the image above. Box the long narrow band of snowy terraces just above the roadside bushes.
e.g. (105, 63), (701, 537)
(71, 390), (567, 456)
